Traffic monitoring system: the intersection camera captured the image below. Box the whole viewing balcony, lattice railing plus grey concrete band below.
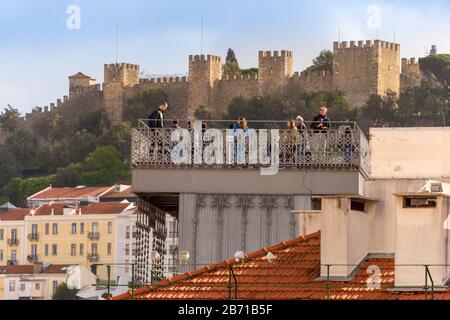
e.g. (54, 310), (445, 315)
(131, 121), (370, 194)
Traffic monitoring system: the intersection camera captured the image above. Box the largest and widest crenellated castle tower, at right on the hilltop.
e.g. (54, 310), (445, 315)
(333, 40), (400, 107)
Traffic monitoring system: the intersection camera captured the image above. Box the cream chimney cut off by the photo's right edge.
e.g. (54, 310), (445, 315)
(394, 181), (450, 290)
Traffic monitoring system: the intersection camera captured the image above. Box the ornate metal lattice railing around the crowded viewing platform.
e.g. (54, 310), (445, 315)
(132, 120), (369, 176)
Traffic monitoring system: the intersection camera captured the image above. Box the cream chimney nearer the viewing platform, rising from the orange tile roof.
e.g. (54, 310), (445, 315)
(320, 195), (377, 281)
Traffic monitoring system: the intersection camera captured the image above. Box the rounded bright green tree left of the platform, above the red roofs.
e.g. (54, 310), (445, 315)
(81, 146), (130, 187)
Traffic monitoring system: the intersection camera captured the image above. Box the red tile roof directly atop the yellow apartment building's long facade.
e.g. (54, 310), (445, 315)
(34, 202), (130, 216)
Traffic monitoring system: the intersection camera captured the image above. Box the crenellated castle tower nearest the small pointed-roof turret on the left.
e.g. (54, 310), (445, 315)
(103, 63), (139, 121)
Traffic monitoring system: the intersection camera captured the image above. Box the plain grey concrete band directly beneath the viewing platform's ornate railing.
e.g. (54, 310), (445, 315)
(132, 168), (364, 196)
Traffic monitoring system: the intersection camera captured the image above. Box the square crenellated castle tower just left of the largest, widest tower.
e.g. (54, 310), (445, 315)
(258, 50), (294, 96)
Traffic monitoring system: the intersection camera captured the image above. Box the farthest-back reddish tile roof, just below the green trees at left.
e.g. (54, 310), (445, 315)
(28, 187), (111, 200)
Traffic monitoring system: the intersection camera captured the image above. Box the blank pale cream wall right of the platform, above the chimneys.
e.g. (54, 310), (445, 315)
(370, 128), (450, 179)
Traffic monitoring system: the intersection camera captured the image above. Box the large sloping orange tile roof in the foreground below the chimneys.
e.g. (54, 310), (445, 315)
(113, 232), (450, 300)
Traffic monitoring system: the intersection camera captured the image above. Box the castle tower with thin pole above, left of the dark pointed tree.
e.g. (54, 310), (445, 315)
(188, 54), (222, 118)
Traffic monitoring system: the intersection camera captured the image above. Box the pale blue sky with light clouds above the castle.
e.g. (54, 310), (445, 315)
(0, 0), (450, 113)
